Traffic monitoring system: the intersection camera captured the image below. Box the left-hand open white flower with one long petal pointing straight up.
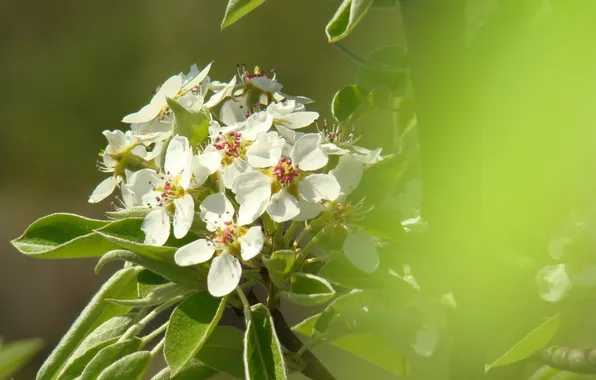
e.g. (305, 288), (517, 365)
(123, 136), (194, 245)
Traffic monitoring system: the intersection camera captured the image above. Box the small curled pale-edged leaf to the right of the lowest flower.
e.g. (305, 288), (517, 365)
(279, 273), (335, 306)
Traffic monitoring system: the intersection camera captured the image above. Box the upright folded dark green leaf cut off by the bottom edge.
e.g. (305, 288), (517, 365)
(244, 304), (287, 380)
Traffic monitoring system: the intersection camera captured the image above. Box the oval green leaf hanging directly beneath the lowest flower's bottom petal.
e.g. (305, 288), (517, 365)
(164, 292), (226, 375)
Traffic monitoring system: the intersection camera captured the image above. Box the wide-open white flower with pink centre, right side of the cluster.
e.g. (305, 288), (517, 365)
(232, 132), (340, 224)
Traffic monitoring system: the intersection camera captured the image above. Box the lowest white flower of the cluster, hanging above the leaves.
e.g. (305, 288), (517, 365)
(174, 193), (265, 297)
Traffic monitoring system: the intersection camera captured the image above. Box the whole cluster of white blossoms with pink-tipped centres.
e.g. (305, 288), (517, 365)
(89, 64), (382, 296)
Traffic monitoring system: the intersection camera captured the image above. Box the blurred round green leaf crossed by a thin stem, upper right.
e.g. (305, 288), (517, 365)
(356, 45), (409, 96)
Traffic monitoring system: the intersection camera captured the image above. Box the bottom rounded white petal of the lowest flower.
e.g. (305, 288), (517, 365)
(207, 253), (242, 297)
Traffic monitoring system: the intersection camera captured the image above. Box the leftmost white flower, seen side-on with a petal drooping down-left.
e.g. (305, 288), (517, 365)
(89, 130), (163, 203)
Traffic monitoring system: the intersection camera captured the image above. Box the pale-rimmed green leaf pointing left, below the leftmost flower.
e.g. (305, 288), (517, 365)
(11, 214), (114, 259)
